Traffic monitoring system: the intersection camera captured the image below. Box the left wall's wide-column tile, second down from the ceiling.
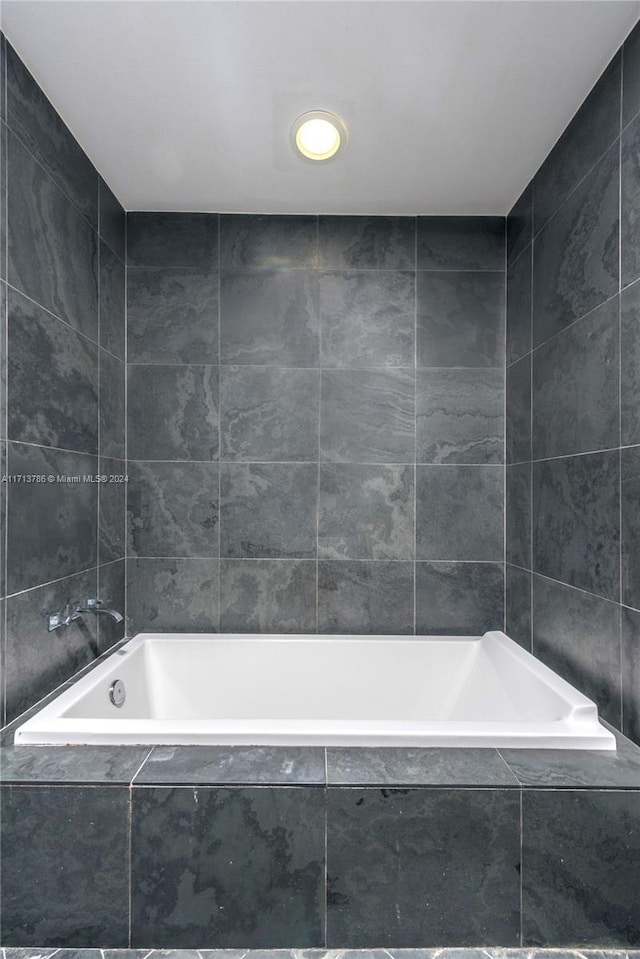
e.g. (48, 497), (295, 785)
(7, 134), (98, 340)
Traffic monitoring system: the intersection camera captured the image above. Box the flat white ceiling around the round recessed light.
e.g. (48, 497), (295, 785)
(1, 0), (640, 214)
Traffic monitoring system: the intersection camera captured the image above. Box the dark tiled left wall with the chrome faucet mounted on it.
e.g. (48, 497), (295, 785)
(0, 38), (126, 724)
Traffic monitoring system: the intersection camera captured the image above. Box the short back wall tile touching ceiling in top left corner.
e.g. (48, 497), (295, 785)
(127, 212), (218, 270)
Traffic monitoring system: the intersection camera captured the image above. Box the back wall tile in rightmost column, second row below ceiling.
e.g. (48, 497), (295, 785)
(416, 272), (505, 367)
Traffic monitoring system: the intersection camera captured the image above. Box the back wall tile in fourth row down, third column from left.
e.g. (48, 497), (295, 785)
(318, 463), (414, 560)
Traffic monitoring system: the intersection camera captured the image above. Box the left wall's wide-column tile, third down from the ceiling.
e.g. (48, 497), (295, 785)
(7, 290), (98, 453)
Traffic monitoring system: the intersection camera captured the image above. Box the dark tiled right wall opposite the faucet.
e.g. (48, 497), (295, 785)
(506, 18), (640, 748)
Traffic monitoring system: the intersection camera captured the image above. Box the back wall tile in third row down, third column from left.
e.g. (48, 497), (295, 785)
(320, 370), (415, 463)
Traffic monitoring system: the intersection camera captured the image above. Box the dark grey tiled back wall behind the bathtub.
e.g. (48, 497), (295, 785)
(127, 213), (505, 633)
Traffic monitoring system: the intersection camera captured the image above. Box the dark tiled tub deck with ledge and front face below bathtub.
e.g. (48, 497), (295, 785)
(1, 736), (640, 950)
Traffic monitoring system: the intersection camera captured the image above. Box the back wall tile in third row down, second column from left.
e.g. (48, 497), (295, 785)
(220, 366), (320, 462)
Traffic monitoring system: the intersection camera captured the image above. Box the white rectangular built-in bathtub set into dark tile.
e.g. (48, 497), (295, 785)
(15, 632), (615, 749)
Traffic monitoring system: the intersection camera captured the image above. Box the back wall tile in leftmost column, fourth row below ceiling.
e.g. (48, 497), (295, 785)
(127, 462), (218, 557)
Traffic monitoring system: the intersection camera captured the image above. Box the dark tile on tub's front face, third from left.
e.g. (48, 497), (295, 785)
(327, 787), (520, 948)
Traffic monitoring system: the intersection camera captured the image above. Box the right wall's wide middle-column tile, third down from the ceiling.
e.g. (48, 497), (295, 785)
(533, 296), (620, 459)
